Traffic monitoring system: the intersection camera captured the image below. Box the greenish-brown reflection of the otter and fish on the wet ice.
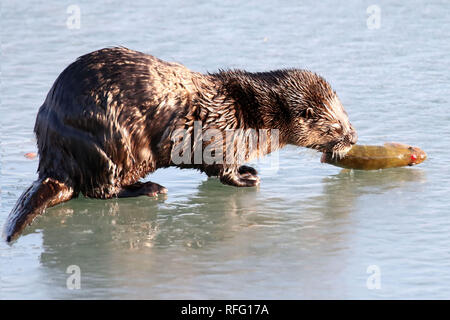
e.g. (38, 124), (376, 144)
(28, 168), (425, 298)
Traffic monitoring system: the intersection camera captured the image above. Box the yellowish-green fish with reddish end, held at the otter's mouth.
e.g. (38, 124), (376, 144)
(320, 142), (427, 170)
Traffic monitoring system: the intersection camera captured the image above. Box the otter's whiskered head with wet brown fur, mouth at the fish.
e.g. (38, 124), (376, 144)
(283, 70), (358, 157)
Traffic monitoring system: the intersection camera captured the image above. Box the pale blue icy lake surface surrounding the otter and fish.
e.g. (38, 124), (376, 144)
(0, 0), (450, 299)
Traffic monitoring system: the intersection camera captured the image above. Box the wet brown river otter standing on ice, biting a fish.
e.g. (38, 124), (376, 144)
(4, 47), (357, 242)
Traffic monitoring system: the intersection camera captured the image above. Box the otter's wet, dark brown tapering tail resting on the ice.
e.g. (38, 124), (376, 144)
(3, 178), (74, 242)
